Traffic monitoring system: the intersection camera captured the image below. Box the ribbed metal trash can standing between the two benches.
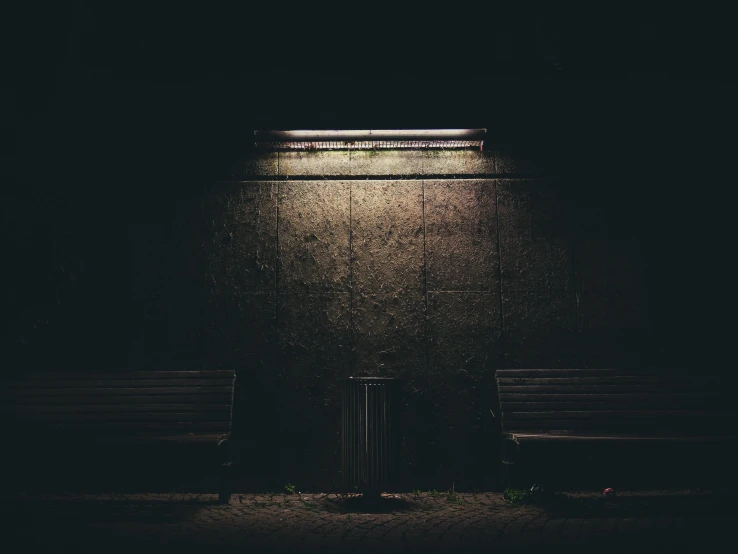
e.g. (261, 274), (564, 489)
(341, 377), (397, 496)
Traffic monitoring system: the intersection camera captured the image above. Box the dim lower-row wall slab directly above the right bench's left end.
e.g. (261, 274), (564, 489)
(502, 291), (579, 368)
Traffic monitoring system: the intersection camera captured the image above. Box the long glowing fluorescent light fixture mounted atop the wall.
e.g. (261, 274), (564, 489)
(254, 129), (487, 150)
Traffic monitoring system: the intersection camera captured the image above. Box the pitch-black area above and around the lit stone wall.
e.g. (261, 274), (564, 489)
(0, 6), (736, 488)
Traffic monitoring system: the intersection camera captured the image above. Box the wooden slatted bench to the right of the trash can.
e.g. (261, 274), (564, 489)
(496, 369), (738, 488)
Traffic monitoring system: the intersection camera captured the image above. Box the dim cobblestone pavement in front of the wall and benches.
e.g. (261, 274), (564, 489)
(2, 491), (738, 552)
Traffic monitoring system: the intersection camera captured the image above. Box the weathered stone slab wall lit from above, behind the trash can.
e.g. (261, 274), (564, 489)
(202, 151), (647, 490)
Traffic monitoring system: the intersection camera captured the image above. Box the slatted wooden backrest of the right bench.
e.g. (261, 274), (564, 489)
(496, 369), (735, 436)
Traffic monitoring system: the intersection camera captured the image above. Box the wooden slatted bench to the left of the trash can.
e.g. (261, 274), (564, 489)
(2, 370), (235, 502)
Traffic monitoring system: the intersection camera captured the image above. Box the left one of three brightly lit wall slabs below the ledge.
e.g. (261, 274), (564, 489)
(279, 181), (350, 293)
